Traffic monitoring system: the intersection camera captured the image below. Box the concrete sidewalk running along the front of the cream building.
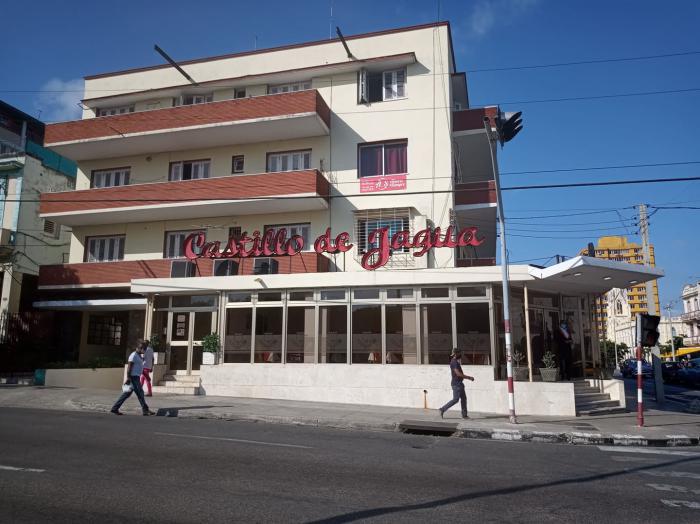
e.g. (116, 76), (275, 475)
(0, 385), (700, 446)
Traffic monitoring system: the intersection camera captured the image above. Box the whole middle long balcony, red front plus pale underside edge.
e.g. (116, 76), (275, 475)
(39, 169), (330, 226)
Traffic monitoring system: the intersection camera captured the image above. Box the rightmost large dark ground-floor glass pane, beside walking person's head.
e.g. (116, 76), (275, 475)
(456, 302), (491, 365)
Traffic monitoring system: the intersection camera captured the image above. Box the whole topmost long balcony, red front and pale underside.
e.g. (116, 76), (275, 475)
(45, 90), (330, 161)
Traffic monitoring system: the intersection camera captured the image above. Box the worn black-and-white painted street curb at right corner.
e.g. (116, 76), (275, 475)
(454, 428), (700, 447)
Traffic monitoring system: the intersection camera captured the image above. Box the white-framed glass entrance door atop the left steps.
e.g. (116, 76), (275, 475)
(170, 311), (214, 375)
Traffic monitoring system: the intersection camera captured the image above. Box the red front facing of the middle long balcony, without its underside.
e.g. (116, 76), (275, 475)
(39, 169), (329, 213)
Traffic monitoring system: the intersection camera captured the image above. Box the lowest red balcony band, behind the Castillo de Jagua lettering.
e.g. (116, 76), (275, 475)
(39, 251), (329, 286)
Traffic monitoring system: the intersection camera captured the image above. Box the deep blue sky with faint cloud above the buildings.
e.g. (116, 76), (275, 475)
(0, 0), (700, 312)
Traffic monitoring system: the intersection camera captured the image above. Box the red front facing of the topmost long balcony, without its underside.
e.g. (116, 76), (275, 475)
(45, 89), (331, 146)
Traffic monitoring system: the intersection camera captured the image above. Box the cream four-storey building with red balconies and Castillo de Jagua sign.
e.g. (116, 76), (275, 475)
(37, 22), (663, 415)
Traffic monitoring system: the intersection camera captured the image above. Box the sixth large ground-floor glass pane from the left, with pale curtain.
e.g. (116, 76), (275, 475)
(385, 304), (418, 364)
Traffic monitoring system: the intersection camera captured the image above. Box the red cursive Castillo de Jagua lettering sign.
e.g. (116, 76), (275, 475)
(184, 226), (484, 270)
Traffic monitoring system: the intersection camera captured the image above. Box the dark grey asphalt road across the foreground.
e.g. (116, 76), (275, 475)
(0, 409), (700, 524)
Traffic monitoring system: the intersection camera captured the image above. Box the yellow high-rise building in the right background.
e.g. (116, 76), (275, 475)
(580, 236), (661, 339)
